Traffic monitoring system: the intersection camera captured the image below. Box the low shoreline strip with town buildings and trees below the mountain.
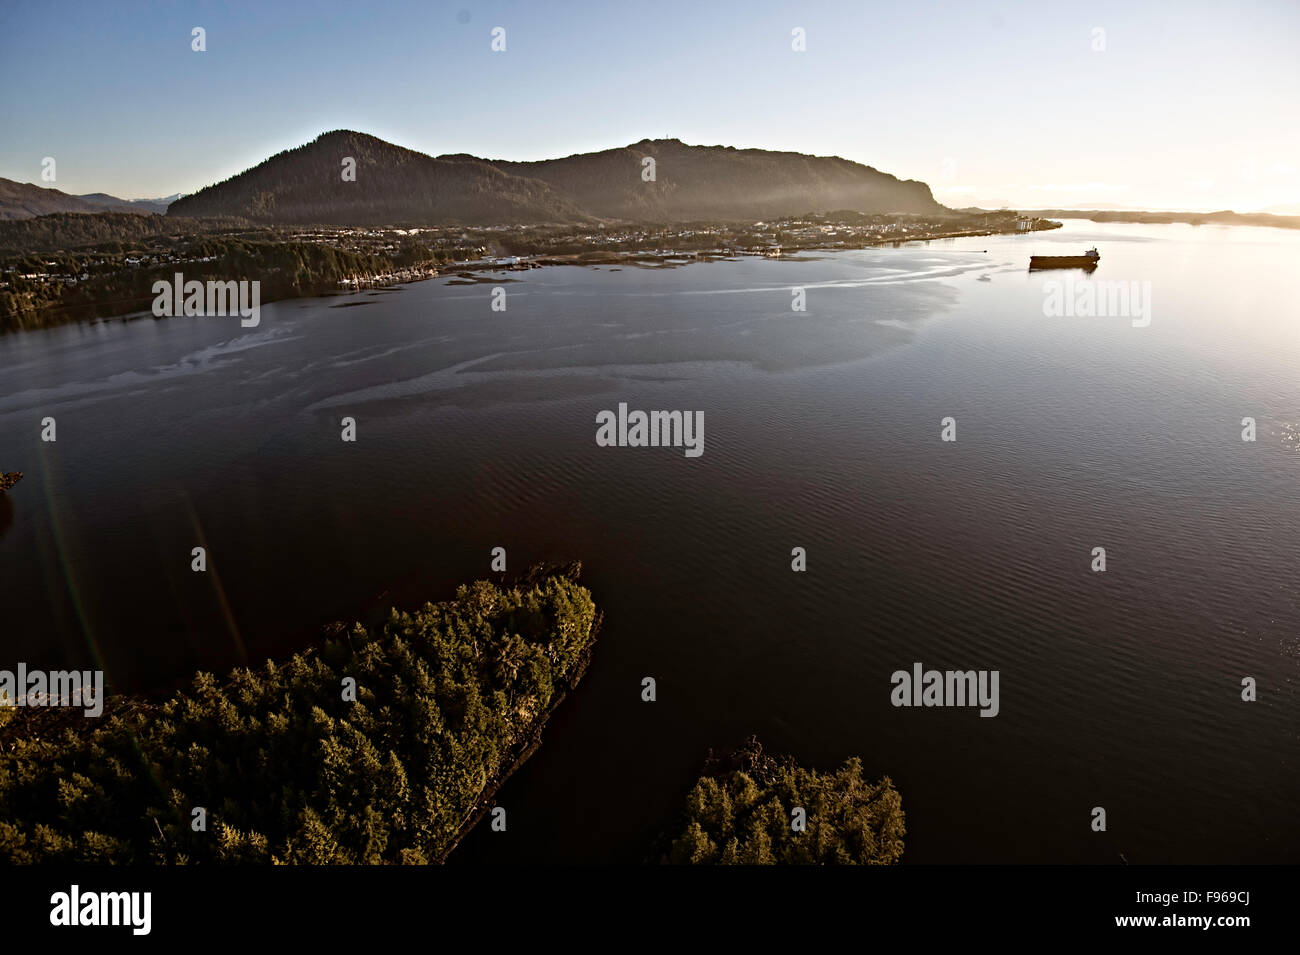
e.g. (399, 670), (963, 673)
(0, 209), (1060, 329)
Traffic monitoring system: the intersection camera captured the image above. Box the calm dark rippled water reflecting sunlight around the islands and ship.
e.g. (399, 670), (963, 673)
(0, 221), (1300, 863)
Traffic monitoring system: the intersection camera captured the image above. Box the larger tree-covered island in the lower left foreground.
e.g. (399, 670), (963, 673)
(0, 564), (599, 864)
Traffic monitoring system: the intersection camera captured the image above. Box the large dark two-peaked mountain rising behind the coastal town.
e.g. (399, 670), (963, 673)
(168, 130), (948, 226)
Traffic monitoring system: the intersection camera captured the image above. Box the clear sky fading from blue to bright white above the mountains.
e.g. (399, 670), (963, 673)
(0, 0), (1300, 213)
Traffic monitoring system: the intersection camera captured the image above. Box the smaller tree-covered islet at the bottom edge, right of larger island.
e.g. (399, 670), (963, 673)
(657, 737), (907, 865)
